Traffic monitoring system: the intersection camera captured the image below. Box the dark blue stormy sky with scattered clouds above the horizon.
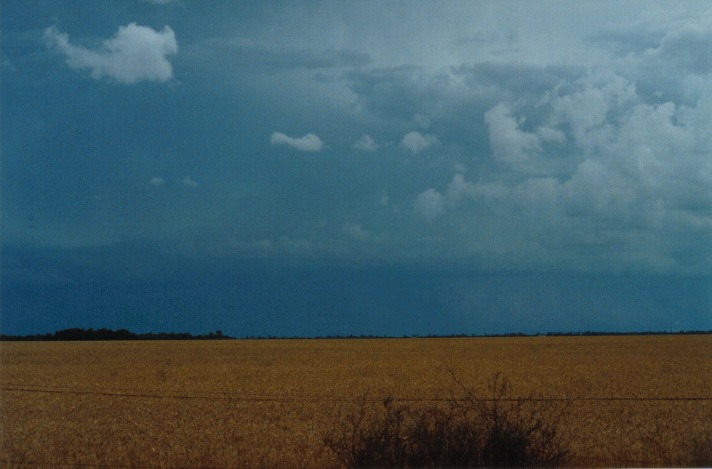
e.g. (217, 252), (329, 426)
(0, 0), (712, 336)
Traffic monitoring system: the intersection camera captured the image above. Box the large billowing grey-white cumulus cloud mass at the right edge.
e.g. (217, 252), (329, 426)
(406, 60), (712, 272)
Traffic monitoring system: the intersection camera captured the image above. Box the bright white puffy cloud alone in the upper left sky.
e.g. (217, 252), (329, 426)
(44, 23), (178, 85)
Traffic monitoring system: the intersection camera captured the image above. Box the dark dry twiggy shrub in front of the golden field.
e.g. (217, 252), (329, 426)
(324, 375), (567, 467)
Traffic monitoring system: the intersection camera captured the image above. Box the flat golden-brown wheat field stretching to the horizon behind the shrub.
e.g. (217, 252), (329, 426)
(0, 335), (712, 467)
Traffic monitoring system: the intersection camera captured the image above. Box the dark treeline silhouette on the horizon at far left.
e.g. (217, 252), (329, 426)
(0, 327), (234, 341)
